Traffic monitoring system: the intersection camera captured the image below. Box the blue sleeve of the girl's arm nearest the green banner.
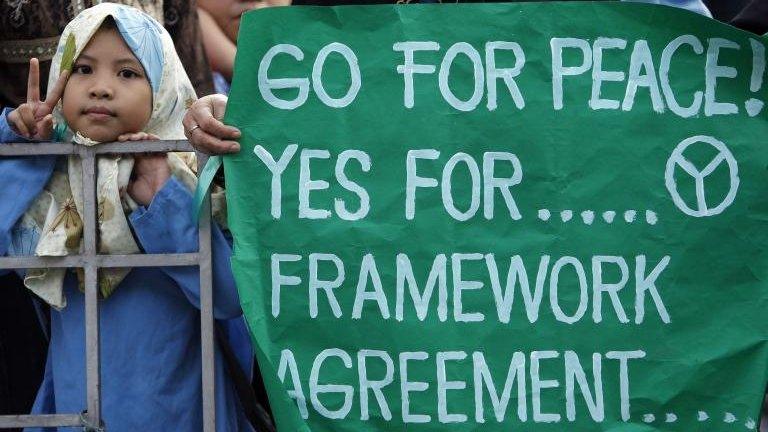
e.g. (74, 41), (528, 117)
(130, 177), (242, 319)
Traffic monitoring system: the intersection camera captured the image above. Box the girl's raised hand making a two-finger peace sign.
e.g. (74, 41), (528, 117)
(8, 58), (69, 141)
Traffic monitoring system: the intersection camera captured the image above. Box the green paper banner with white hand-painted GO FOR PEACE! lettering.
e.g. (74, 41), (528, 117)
(224, 2), (768, 432)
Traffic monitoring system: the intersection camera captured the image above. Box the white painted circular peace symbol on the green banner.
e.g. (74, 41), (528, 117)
(664, 135), (739, 217)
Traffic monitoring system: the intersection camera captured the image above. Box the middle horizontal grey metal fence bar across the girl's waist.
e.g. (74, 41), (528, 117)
(0, 253), (200, 269)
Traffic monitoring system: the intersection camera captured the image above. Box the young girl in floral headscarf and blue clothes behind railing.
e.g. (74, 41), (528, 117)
(0, 3), (251, 432)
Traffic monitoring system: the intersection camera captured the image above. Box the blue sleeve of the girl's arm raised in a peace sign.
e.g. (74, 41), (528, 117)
(0, 108), (56, 256)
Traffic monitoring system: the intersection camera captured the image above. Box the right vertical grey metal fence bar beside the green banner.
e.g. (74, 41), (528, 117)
(198, 154), (216, 432)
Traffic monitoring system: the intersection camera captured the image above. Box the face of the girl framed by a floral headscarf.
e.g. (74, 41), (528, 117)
(62, 26), (152, 142)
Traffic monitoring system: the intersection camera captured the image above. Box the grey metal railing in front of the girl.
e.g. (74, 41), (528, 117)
(0, 141), (216, 432)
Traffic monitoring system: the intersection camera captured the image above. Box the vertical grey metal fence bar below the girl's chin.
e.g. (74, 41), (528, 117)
(82, 151), (101, 429)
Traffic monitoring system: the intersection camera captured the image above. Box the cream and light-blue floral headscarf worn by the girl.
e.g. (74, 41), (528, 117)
(9, 3), (207, 308)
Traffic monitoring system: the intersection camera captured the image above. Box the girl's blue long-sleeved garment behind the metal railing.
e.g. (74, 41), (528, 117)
(0, 109), (253, 432)
